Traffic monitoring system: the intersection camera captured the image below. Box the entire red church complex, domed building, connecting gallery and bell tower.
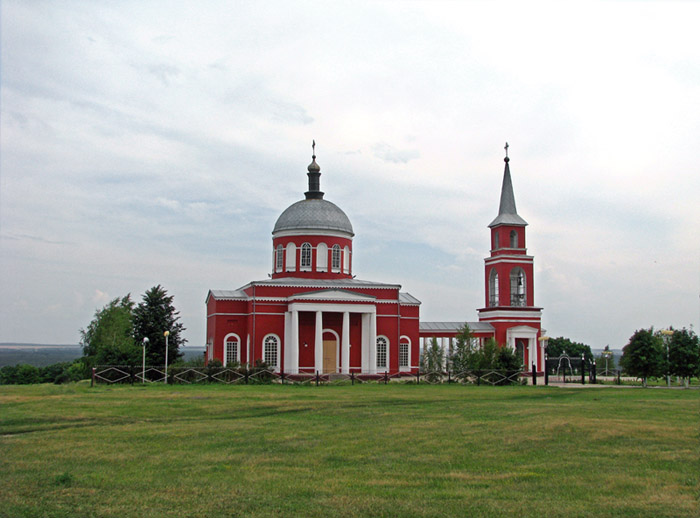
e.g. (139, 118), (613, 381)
(206, 144), (544, 375)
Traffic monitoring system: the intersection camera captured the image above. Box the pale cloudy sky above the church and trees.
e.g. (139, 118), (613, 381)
(0, 0), (700, 348)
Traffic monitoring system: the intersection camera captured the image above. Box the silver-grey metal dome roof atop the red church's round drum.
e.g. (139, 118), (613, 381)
(272, 199), (355, 237)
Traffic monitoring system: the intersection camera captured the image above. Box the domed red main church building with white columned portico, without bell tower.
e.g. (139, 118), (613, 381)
(206, 148), (420, 374)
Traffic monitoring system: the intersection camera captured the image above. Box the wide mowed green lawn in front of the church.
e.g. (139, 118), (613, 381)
(0, 385), (700, 518)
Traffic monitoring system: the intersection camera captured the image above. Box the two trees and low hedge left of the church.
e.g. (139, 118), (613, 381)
(0, 285), (186, 384)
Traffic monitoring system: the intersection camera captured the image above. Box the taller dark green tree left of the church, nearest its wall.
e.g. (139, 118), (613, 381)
(133, 285), (187, 365)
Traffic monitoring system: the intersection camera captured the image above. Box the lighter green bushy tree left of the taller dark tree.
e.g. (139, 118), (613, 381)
(80, 295), (140, 368)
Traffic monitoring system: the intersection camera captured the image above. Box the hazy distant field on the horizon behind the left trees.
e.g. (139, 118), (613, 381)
(0, 343), (204, 367)
